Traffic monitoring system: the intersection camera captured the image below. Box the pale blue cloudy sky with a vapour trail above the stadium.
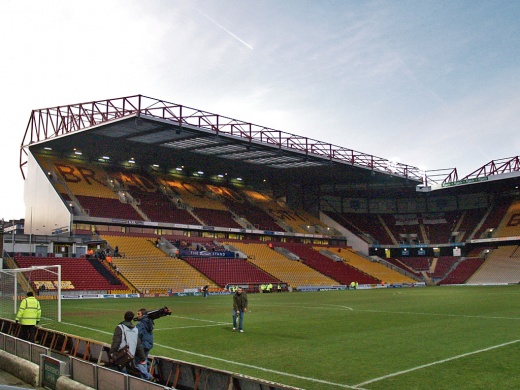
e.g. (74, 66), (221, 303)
(0, 0), (520, 220)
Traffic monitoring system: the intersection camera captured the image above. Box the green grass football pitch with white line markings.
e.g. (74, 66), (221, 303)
(38, 286), (520, 389)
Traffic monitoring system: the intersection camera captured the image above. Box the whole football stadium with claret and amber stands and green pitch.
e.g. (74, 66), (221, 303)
(0, 95), (520, 390)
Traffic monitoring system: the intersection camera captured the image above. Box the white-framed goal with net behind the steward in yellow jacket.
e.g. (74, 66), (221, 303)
(0, 265), (61, 326)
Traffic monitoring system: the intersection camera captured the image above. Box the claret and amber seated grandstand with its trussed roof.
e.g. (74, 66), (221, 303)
(4, 95), (520, 293)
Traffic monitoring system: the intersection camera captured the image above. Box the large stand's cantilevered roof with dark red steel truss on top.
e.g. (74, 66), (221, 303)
(20, 95), (423, 192)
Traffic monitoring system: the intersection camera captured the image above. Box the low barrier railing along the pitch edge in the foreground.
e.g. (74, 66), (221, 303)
(0, 318), (297, 390)
